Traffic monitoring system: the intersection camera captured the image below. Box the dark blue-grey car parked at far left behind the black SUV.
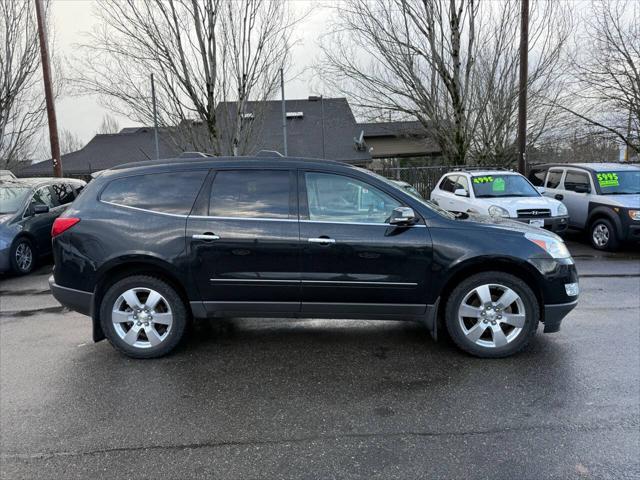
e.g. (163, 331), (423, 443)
(0, 178), (85, 275)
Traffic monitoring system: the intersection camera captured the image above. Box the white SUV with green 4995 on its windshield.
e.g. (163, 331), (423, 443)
(431, 170), (568, 233)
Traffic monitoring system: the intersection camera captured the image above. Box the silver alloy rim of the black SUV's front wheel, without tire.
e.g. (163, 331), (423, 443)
(458, 284), (526, 348)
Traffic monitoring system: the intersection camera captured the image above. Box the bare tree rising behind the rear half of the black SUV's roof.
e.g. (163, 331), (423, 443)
(75, 0), (296, 154)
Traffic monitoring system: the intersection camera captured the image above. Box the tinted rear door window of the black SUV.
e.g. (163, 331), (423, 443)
(209, 170), (290, 218)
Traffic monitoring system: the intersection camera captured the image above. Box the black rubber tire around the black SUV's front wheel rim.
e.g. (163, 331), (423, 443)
(445, 272), (540, 358)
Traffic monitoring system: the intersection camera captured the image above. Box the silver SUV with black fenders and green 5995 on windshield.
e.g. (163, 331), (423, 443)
(529, 163), (640, 250)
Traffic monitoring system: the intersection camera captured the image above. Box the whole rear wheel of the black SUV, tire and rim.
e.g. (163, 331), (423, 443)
(100, 275), (187, 358)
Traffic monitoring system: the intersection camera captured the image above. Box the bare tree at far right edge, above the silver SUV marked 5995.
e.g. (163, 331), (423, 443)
(559, 0), (640, 154)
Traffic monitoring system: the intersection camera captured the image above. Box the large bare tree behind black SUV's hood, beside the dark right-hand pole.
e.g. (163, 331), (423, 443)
(318, 0), (567, 164)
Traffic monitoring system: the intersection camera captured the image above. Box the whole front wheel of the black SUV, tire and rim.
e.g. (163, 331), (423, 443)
(445, 272), (540, 358)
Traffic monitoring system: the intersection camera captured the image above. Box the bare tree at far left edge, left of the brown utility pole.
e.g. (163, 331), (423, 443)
(0, 0), (45, 169)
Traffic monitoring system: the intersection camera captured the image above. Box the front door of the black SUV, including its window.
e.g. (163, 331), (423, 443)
(298, 170), (432, 316)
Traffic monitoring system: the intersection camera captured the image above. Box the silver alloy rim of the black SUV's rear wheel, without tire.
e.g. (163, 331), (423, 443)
(111, 288), (173, 348)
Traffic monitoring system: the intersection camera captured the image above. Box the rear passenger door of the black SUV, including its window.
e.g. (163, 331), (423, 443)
(187, 169), (301, 314)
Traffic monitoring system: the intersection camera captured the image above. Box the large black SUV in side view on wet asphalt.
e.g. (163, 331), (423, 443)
(50, 157), (578, 358)
